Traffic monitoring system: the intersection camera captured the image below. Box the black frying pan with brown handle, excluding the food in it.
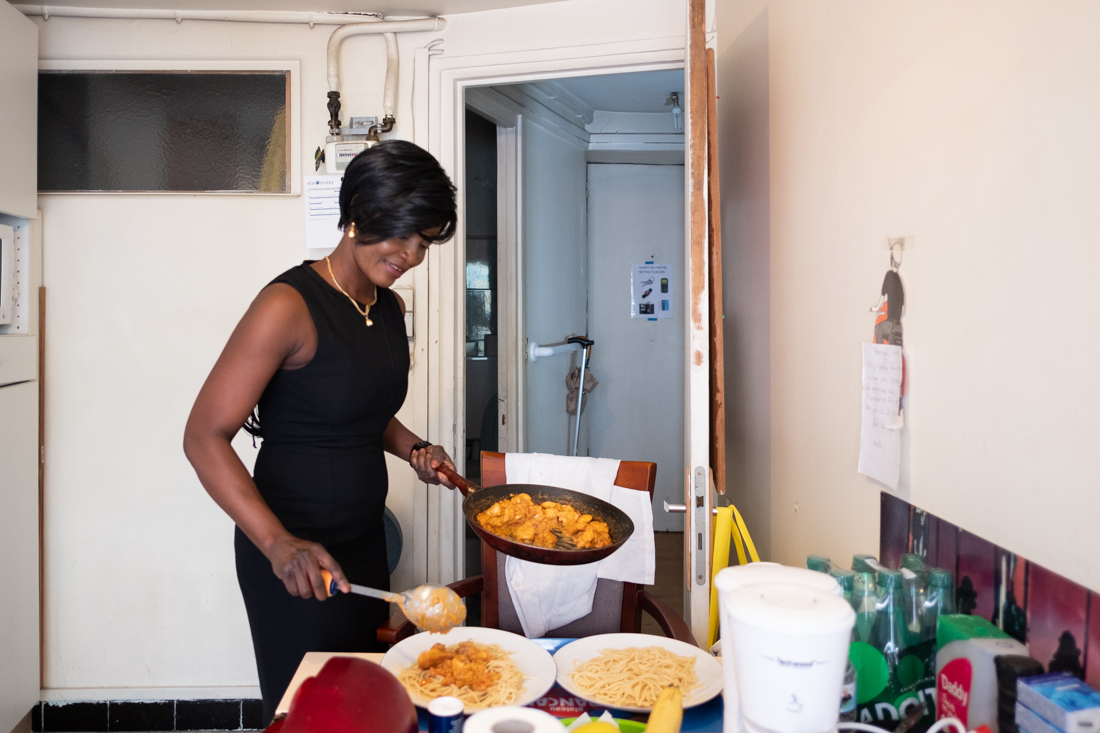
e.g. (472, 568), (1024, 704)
(438, 466), (634, 565)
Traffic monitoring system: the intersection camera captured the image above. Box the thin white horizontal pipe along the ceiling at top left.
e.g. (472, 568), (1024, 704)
(12, 6), (384, 28)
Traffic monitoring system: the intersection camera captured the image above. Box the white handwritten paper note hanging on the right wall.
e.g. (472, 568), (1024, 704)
(857, 343), (904, 491)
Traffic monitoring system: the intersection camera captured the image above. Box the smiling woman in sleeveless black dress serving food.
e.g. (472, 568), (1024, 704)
(184, 141), (457, 721)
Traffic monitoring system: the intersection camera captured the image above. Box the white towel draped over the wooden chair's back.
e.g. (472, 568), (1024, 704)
(504, 453), (656, 638)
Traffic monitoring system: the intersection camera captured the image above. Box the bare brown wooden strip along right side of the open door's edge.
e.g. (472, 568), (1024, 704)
(706, 48), (726, 494)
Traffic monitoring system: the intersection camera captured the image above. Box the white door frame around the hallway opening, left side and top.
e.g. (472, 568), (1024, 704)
(416, 35), (686, 583)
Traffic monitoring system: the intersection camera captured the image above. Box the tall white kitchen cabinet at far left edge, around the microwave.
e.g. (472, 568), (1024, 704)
(0, 2), (40, 731)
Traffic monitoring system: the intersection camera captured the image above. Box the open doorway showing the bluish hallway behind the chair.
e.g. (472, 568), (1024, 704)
(464, 69), (686, 621)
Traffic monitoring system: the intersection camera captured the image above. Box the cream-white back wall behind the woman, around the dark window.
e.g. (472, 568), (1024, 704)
(35, 0), (683, 699)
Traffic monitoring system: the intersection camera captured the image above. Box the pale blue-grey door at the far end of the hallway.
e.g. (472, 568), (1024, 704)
(581, 162), (685, 532)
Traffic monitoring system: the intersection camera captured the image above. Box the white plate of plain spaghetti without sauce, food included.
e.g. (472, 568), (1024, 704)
(553, 634), (722, 712)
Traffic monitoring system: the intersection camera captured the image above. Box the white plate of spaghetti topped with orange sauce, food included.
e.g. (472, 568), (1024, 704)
(382, 626), (557, 715)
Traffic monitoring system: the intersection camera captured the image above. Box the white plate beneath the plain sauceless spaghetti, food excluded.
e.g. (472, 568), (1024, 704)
(553, 634), (722, 712)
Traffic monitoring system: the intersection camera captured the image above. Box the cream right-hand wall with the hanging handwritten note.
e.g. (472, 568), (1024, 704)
(718, 0), (1100, 589)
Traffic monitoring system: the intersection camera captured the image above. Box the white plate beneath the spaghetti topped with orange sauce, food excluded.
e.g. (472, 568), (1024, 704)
(382, 626), (557, 715)
